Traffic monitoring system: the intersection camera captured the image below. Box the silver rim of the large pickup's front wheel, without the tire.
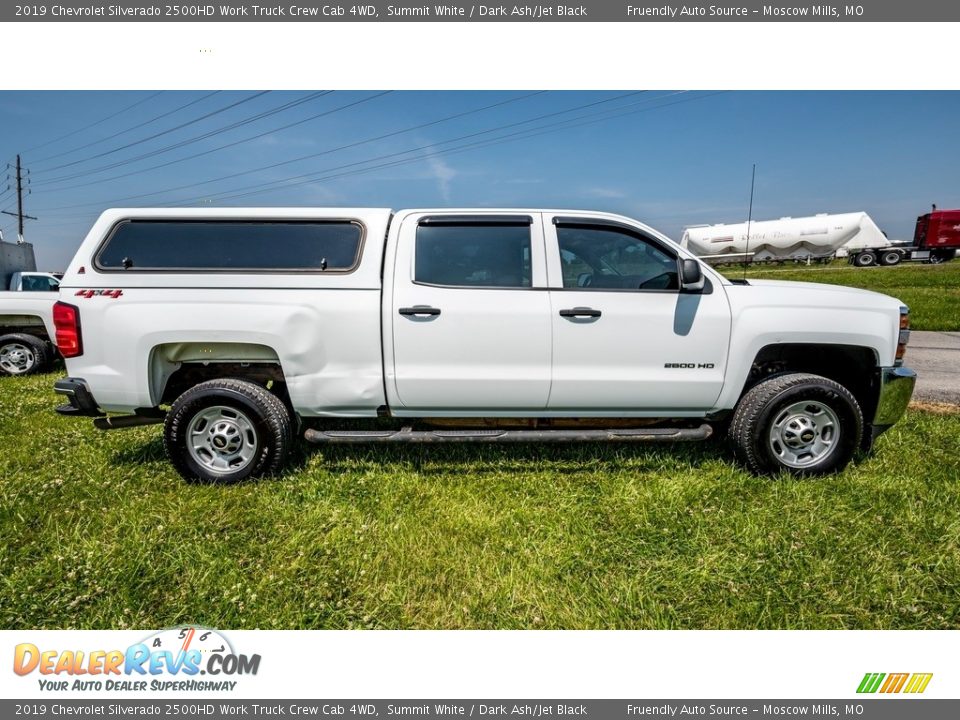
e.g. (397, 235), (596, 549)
(768, 401), (840, 468)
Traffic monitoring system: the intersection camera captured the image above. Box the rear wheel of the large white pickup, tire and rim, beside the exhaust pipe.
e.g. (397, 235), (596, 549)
(163, 379), (293, 483)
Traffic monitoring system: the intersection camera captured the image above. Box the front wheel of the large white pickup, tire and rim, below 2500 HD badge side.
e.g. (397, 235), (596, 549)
(730, 373), (864, 477)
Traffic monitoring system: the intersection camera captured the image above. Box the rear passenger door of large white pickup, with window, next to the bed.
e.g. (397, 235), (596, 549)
(388, 214), (551, 415)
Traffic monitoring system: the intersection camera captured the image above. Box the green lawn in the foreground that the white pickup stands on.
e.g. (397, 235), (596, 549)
(0, 375), (960, 628)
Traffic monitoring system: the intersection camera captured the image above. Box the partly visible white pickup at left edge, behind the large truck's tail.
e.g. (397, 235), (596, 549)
(0, 272), (60, 375)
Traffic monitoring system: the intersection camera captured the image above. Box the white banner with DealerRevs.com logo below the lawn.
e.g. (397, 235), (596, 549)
(0, 628), (960, 699)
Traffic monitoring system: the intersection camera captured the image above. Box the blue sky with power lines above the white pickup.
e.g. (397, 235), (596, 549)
(0, 90), (960, 270)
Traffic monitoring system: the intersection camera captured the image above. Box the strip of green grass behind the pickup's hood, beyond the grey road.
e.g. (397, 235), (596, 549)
(719, 260), (960, 330)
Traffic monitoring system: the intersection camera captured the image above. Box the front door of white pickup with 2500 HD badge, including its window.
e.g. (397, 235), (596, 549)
(544, 219), (730, 413)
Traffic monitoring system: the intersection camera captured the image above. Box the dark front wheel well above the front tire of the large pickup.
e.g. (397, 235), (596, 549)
(741, 343), (879, 418)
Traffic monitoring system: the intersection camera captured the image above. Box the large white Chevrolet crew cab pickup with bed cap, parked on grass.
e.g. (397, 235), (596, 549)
(54, 208), (916, 482)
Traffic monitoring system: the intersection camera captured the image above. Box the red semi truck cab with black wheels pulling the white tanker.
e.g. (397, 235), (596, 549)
(848, 209), (960, 267)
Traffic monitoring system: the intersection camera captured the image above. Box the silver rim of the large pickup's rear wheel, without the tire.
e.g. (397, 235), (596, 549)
(187, 405), (257, 475)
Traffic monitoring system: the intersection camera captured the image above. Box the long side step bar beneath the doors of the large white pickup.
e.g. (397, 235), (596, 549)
(303, 424), (713, 445)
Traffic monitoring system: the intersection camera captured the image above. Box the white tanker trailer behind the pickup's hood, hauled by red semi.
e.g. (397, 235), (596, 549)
(680, 212), (891, 263)
